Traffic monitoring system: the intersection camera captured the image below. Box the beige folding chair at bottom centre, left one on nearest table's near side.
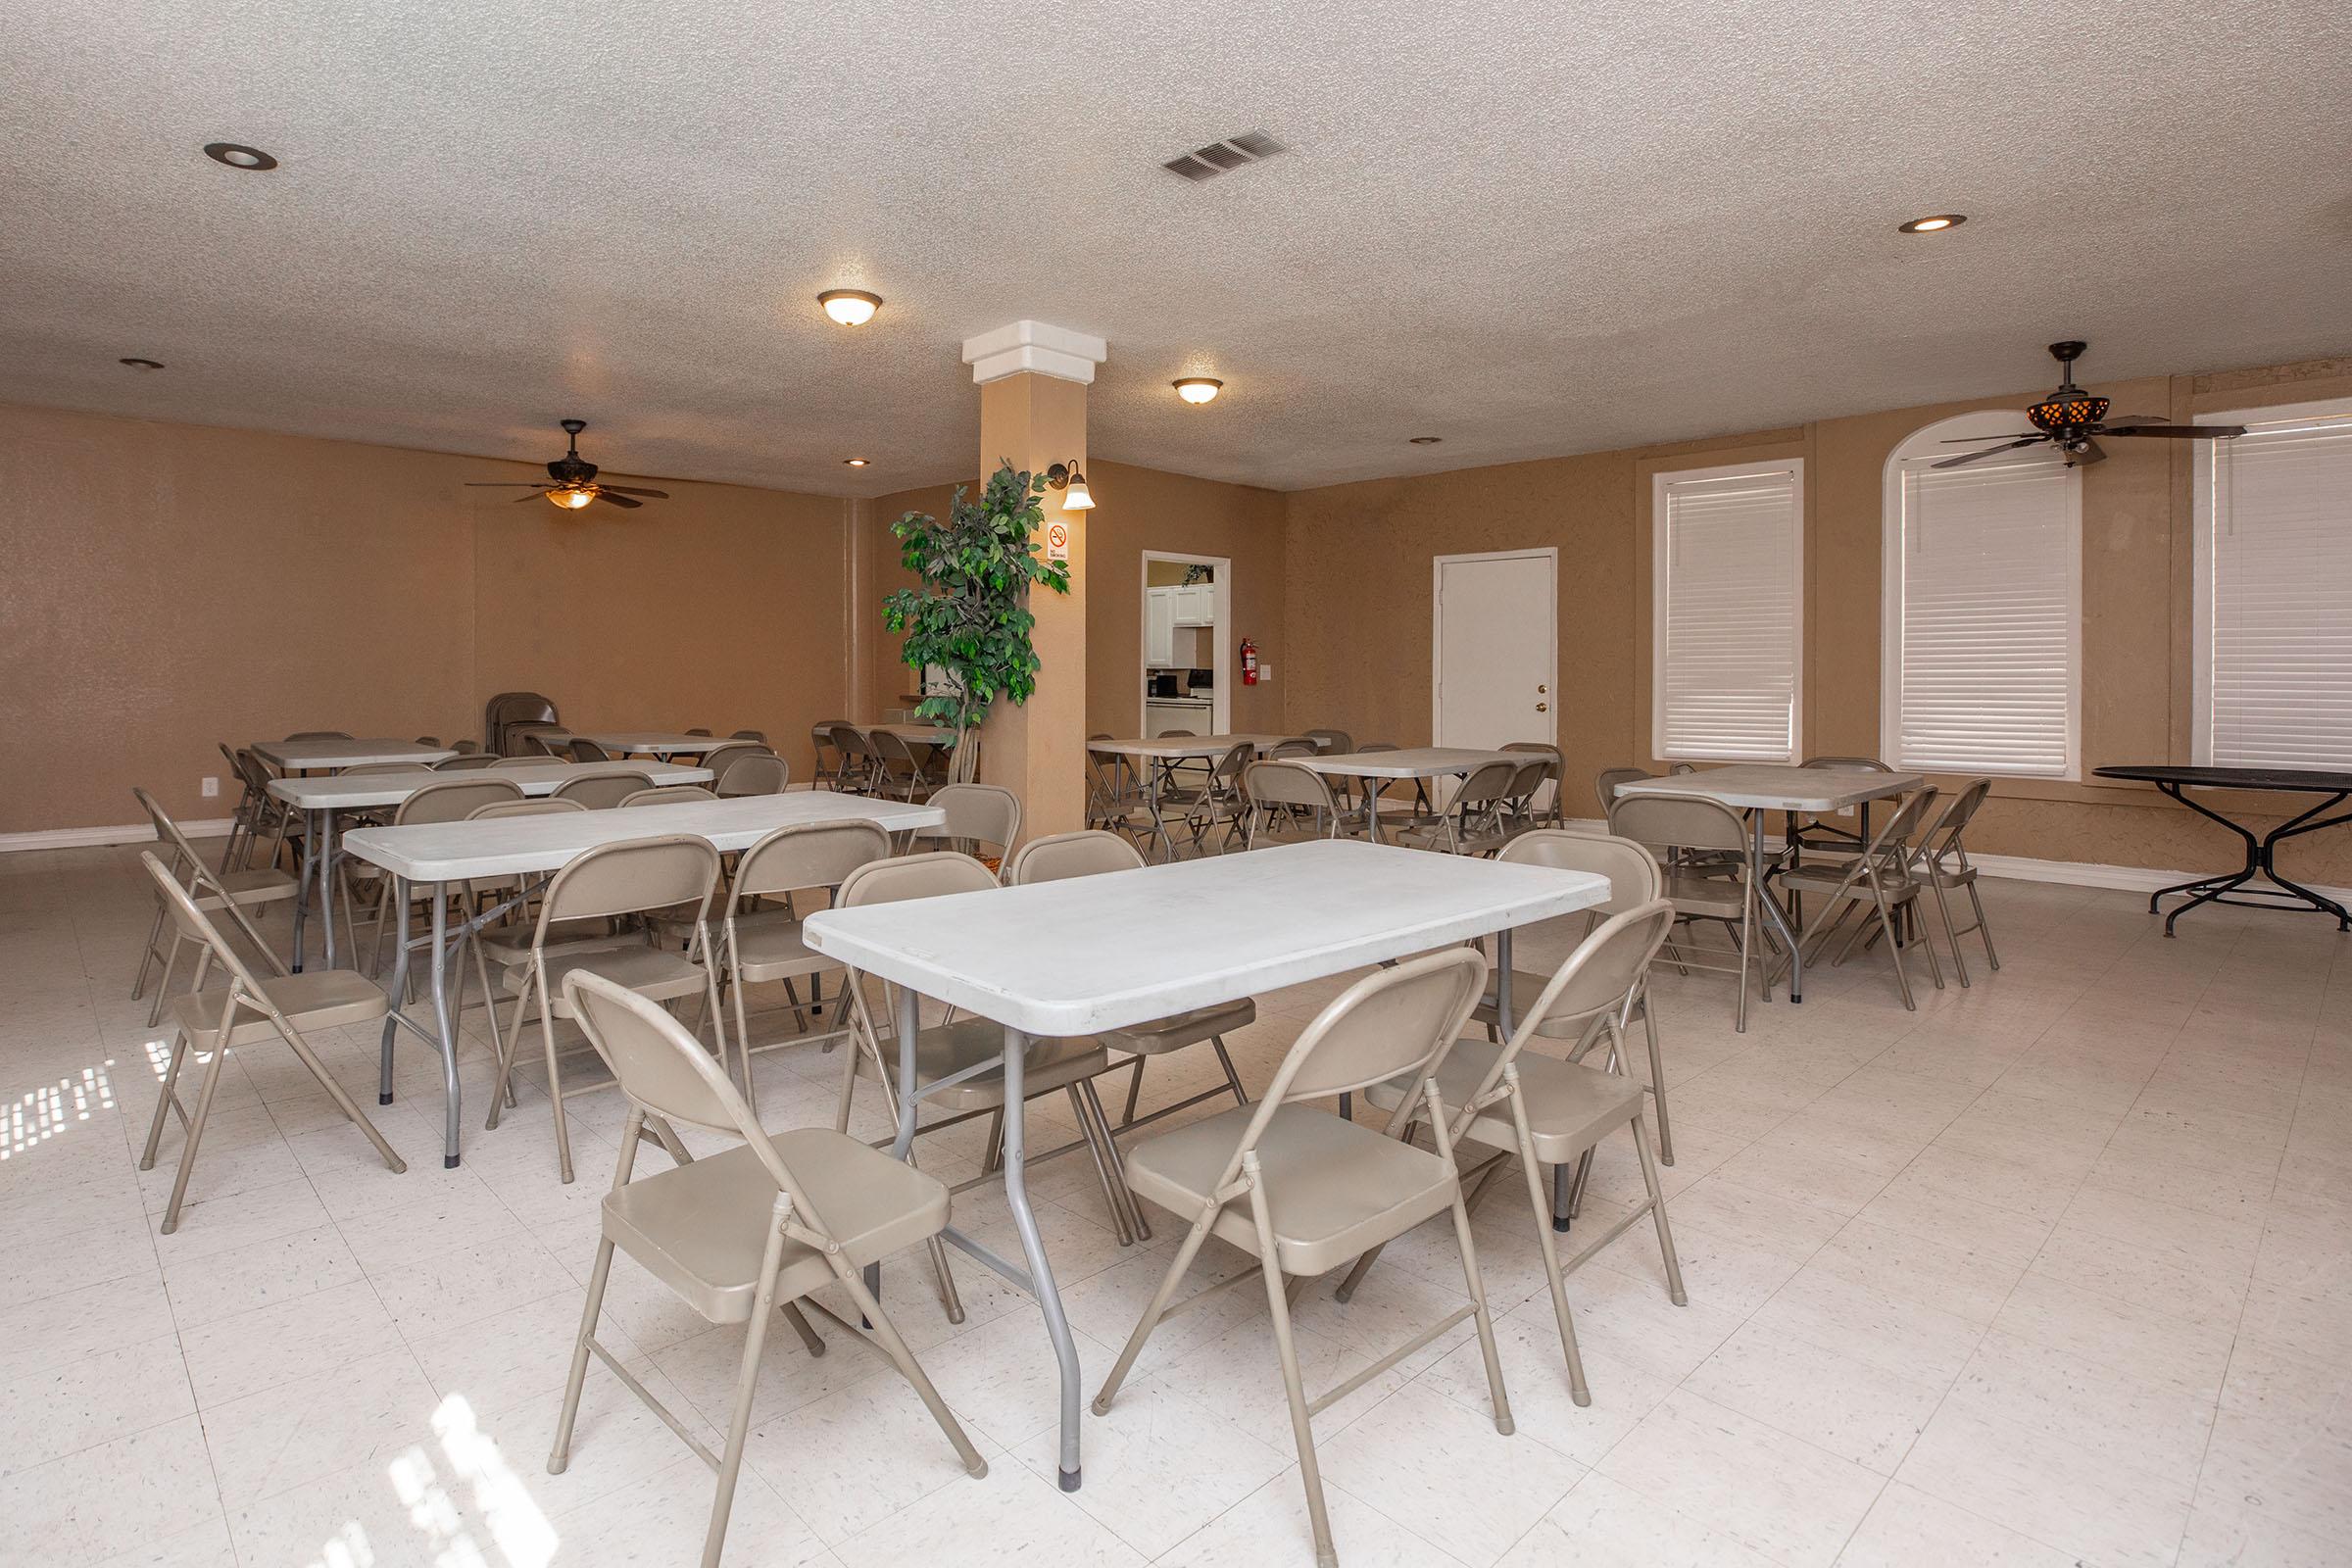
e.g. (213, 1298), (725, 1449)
(1094, 948), (1514, 1566)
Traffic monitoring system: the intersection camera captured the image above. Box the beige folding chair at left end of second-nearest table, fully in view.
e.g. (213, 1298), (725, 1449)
(139, 851), (407, 1237)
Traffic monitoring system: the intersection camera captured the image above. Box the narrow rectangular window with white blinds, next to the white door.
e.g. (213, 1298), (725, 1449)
(1651, 459), (1804, 761)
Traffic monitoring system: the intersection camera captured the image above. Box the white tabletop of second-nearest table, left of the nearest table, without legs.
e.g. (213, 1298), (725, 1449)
(343, 790), (948, 882)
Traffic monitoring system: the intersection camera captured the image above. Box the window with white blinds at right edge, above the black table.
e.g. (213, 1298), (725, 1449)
(2194, 402), (2352, 768)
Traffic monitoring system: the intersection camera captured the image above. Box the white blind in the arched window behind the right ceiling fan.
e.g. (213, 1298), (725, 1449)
(1886, 447), (2080, 778)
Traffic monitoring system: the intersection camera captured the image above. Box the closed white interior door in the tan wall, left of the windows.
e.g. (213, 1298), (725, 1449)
(1430, 550), (1559, 748)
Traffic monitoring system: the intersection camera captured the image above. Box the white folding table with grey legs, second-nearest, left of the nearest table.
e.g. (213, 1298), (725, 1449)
(343, 799), (948, 1166)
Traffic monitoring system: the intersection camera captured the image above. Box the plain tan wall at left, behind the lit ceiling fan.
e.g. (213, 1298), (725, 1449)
(0, 405), (849, 832)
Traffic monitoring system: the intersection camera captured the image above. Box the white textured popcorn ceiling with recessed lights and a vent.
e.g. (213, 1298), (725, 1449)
(0, 0), (2352, 494)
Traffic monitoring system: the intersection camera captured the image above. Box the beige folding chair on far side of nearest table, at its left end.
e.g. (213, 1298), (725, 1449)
(833, 849), (1151, 1241)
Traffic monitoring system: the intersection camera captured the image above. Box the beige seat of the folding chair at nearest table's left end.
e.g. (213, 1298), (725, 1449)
(605, 1126), (948, 1324)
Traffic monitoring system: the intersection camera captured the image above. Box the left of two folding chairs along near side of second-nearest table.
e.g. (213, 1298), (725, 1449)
(487, 835), (727, 1183)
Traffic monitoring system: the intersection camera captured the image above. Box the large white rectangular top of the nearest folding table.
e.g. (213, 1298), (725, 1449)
(805, 839), (1609, 1037)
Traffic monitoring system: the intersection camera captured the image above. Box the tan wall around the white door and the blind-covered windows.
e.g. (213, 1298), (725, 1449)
(1282, 360), (2352, 886)
